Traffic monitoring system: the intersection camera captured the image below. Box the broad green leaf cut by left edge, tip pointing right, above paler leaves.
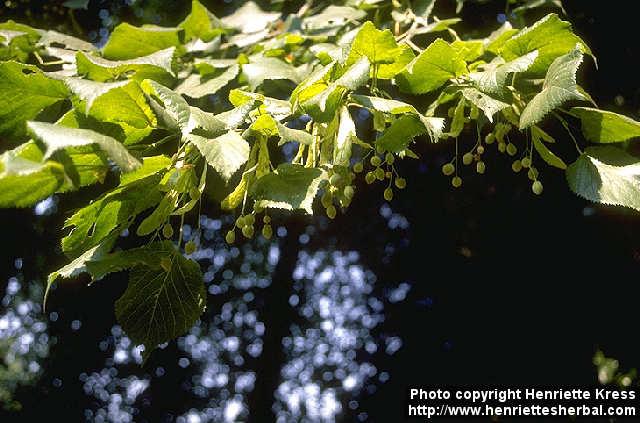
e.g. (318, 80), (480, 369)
(0, 62), (69, 142)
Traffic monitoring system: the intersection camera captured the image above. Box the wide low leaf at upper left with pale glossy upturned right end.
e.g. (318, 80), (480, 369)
(76, 47), (176, 83)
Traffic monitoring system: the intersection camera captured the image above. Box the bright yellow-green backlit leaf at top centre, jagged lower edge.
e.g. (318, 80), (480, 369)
(346, 21), (414, 79)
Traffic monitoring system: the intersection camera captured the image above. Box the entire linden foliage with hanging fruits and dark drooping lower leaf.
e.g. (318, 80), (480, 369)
(0, 0), (640, 357)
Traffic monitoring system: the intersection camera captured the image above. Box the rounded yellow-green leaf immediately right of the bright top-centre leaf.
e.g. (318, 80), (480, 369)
(396, 38), (467, 94)
